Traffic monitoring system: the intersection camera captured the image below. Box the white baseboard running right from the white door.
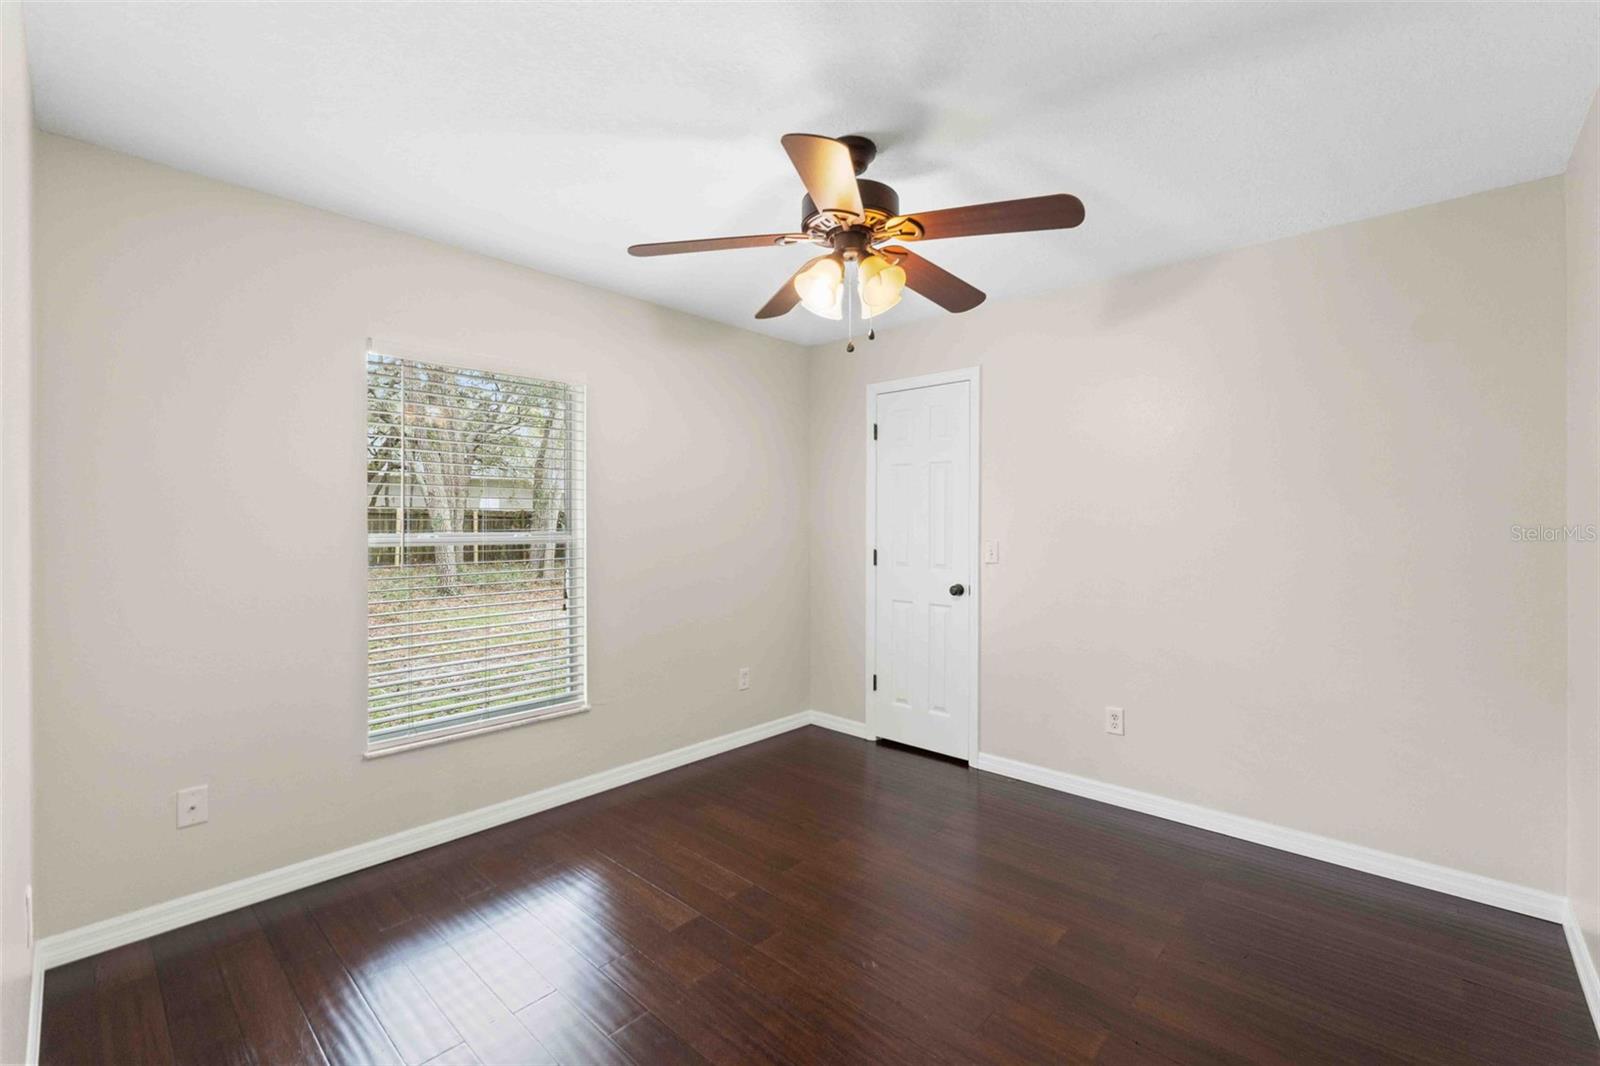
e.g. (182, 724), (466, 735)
(973, 754), (1566, 922)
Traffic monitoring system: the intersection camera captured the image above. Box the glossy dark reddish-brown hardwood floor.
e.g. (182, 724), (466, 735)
(43, 728), (1600, 1066)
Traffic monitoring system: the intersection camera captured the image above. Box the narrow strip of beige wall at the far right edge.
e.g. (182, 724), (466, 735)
(1565, 96), (1600, 959)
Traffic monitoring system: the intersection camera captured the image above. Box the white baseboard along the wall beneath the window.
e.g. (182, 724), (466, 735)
(29, 711), (813, 985)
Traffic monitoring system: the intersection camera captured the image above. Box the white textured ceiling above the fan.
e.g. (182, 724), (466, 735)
(26, 2), (1600, 343)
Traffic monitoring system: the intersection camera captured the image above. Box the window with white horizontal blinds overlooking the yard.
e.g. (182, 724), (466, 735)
(366, 352), (586, 752)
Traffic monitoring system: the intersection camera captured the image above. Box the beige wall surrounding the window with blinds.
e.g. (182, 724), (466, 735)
(35, 134), (806, 933)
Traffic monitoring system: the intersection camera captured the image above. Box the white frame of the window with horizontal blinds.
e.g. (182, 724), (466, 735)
(362, 339), (590, 759)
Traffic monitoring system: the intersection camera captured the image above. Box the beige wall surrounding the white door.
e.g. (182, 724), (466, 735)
(810, 179), (1565, 892)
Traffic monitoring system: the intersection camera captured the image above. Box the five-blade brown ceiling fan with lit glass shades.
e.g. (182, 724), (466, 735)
(627, 133), (1083, 351)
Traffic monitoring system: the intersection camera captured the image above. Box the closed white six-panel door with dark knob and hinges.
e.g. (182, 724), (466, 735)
(869, 372), (978, 759)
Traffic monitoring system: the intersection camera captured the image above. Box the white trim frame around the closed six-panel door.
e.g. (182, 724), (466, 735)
(862, 367), (984, 765)
